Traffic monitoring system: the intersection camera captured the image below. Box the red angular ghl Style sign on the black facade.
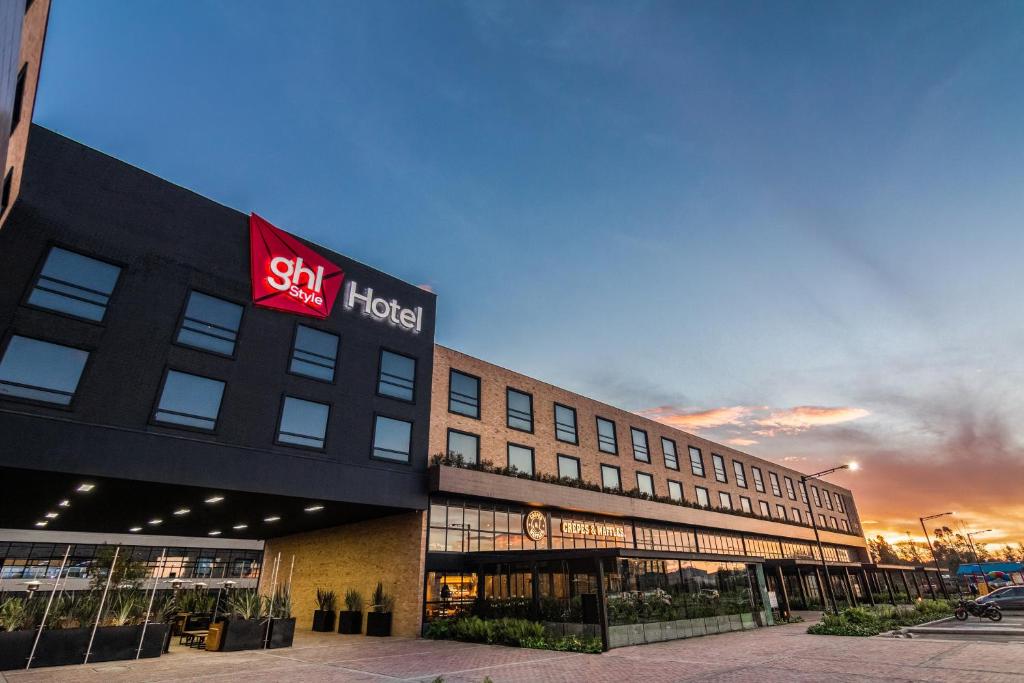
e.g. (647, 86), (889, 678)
(249, 214), (345, 317)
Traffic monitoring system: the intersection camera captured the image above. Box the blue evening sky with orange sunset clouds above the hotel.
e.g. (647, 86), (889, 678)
(36, 0), (1024, 549)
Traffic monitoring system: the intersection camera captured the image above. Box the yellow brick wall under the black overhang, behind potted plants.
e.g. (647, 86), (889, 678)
(260, 512), (426, 638)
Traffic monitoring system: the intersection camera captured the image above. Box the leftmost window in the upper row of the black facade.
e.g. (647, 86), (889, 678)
(28, 247), (121, 322)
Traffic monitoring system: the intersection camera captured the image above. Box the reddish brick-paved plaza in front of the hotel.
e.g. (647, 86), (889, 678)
(0, 624), (1024, 683)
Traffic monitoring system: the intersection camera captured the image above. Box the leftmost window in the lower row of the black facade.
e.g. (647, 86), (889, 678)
(0, 336), (89, 405)
